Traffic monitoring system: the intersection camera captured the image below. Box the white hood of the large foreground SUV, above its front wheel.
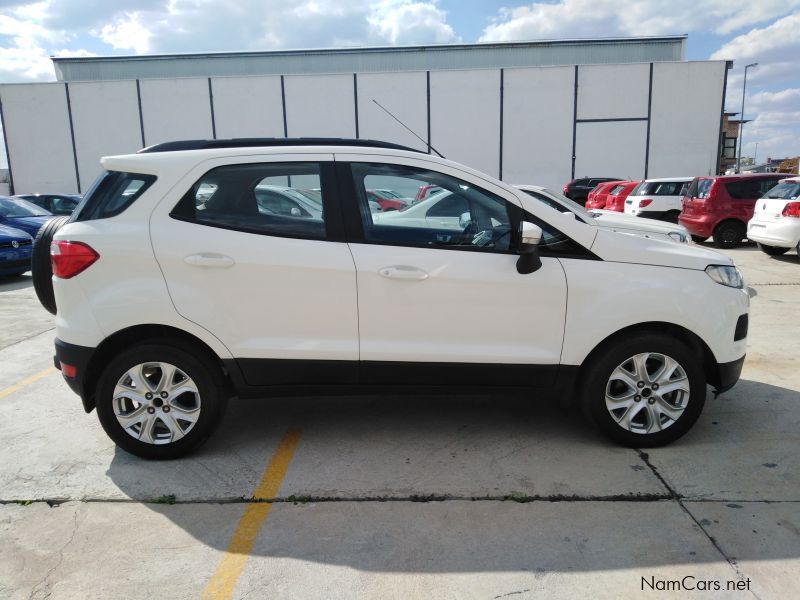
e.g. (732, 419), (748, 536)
(591, 226), (733, 271)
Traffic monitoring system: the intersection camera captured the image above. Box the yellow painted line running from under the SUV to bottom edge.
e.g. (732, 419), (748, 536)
(202, 429), (300, 600)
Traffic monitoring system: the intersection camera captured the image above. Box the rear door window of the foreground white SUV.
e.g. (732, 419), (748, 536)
(170, 163), (325, 239)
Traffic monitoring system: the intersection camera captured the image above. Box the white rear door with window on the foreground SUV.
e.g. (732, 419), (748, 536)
(151, 153), (358, 385)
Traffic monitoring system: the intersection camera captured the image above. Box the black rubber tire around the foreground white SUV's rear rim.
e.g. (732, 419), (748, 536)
(95, 340), (229, 460)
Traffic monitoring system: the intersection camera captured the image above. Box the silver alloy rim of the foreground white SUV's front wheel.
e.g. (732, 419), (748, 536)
(606, 352), (690, 434)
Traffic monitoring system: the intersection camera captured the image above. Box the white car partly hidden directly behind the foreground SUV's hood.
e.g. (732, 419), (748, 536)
(517, 185), (692, 244)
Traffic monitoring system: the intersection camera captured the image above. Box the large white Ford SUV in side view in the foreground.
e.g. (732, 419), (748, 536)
(38, 139), (749, 458)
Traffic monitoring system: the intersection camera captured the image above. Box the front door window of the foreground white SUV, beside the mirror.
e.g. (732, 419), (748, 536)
(351, 163), (516, 252)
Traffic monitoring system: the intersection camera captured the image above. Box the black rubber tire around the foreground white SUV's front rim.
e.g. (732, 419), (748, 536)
(582, 332), (706, 448)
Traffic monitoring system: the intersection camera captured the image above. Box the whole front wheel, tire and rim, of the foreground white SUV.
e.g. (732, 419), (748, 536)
(584, 333), (706, 448)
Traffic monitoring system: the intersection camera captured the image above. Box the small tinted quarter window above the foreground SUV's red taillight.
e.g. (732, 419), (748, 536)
(71, 171), (156, 221)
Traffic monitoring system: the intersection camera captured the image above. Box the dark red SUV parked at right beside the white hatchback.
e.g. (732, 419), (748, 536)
(678, 173), (790, 248)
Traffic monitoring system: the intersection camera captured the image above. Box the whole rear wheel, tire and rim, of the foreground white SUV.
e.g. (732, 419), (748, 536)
(95, 342), (228, 460)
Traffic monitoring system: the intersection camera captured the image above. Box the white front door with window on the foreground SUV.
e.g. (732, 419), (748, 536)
(337, 155), (567, 386)
